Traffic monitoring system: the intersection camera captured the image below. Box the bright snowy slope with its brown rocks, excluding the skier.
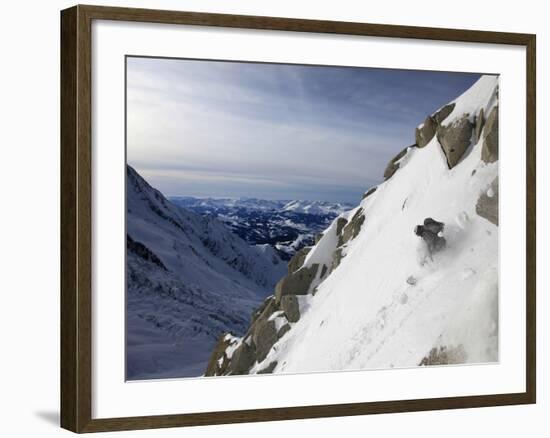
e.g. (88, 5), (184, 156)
(207, 76), (498, 375)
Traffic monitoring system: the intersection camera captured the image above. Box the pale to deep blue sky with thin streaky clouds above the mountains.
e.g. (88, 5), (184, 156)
(127, 57), (480, 204)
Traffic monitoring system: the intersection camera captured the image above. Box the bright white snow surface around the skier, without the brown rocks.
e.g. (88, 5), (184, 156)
(251, 77), (499, 373)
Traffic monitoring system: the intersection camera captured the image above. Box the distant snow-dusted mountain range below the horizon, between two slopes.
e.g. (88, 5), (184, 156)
(169, 196), (352, 260)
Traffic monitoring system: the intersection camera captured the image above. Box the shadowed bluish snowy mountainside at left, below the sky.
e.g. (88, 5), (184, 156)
(126, 166), (286, 379)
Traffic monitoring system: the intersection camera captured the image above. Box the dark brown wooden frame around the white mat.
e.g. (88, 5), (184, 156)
(61, 5), (536, 433)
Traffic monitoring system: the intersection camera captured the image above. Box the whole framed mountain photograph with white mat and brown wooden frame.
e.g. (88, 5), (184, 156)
(61, 6), (536, 432)
